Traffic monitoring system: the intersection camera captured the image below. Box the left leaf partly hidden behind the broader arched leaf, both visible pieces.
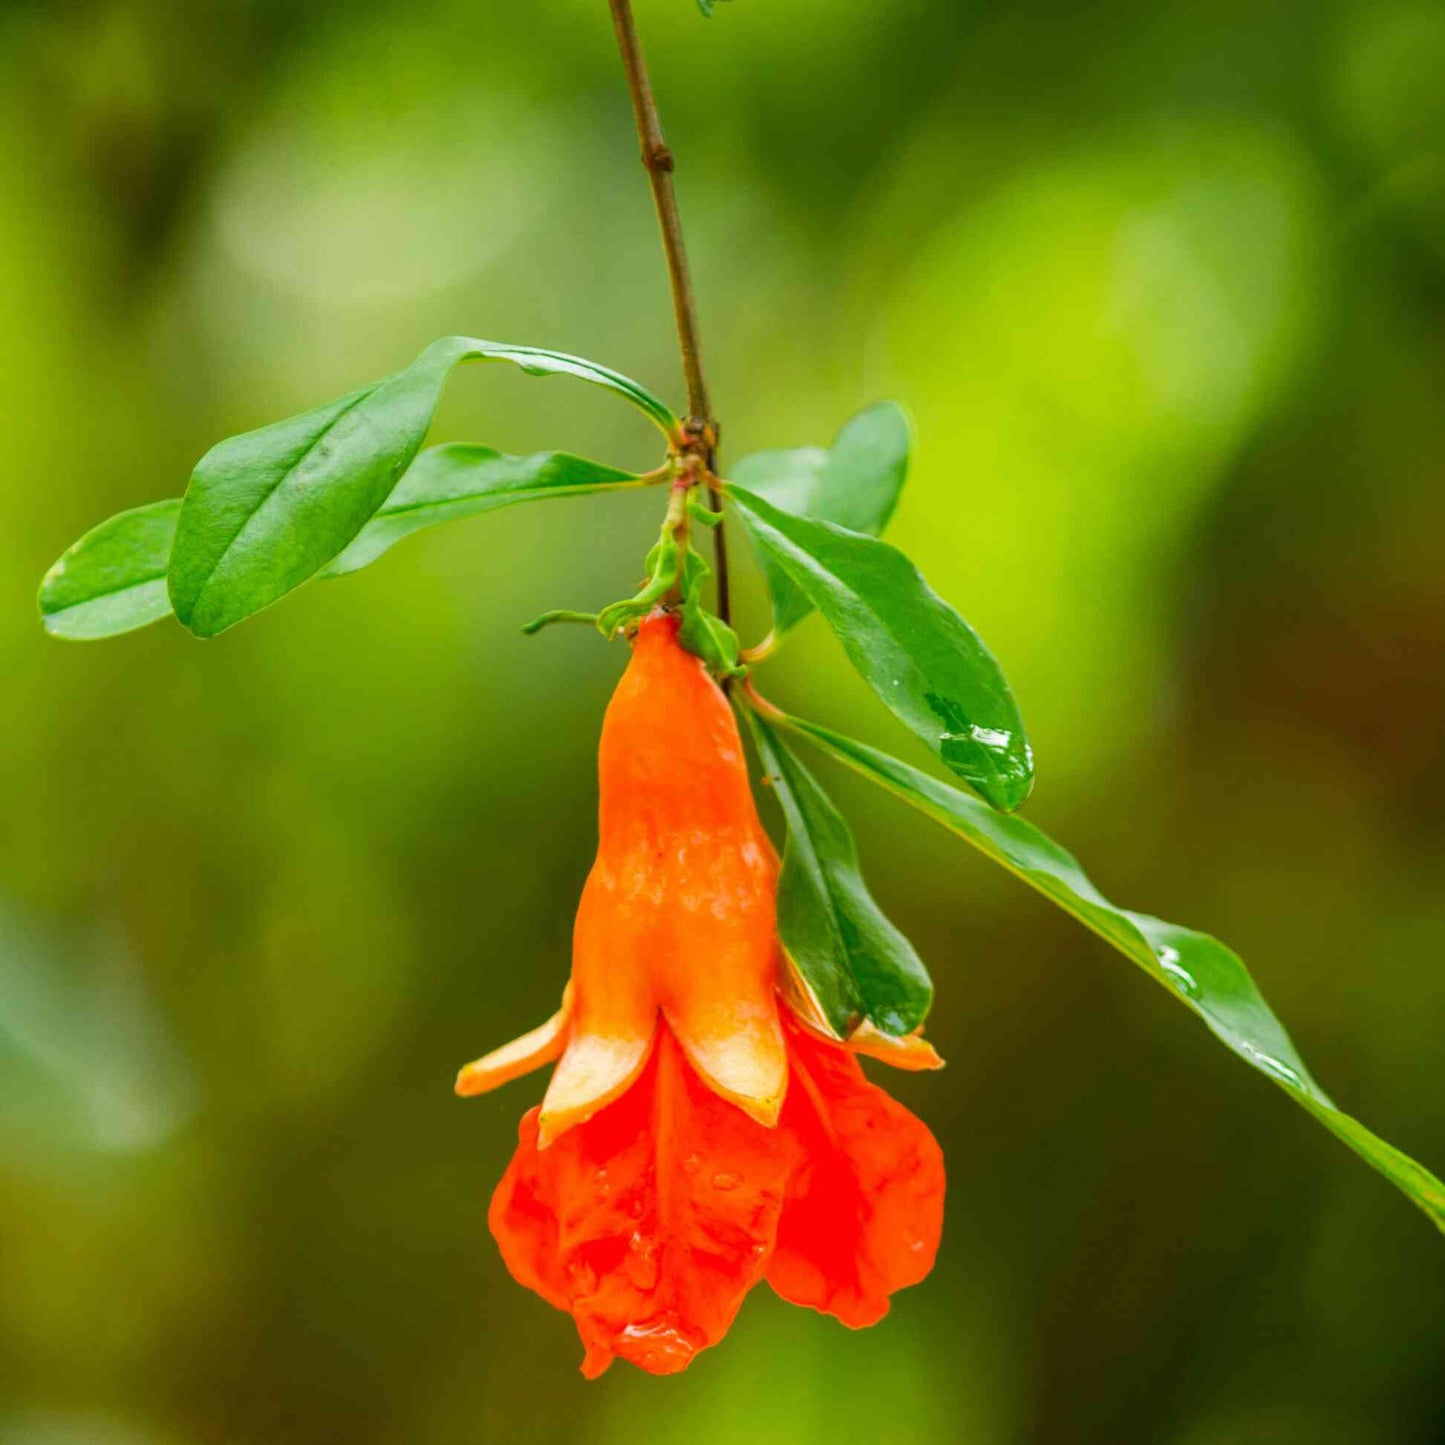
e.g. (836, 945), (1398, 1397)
(39, 445), (646, 639)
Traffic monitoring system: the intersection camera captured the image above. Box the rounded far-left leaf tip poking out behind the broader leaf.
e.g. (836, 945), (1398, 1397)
(39, 497), (181, 640)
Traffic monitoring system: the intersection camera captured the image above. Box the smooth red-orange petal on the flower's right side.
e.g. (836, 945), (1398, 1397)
(767, 1026), (944, 1328)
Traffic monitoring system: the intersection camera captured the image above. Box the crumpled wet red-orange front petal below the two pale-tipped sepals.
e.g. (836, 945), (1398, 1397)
(490, 1029), (796, 1377)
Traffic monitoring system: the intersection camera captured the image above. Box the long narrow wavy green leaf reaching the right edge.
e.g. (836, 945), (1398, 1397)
(769, 712), (1445, 1231)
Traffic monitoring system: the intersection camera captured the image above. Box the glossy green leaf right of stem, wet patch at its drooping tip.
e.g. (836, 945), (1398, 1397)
(725, 483), (1033, 811)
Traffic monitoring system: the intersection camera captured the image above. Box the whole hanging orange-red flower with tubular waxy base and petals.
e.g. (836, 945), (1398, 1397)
(457, 613), (944, 1377)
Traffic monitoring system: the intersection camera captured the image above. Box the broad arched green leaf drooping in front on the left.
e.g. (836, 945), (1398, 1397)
(171, 337), (679, 637)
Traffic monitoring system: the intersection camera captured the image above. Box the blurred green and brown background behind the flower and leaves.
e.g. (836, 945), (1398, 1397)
(0, 0), (1445, 1445)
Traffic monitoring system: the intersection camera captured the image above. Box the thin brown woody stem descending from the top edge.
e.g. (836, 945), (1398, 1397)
(608, 0), (731, 621)
